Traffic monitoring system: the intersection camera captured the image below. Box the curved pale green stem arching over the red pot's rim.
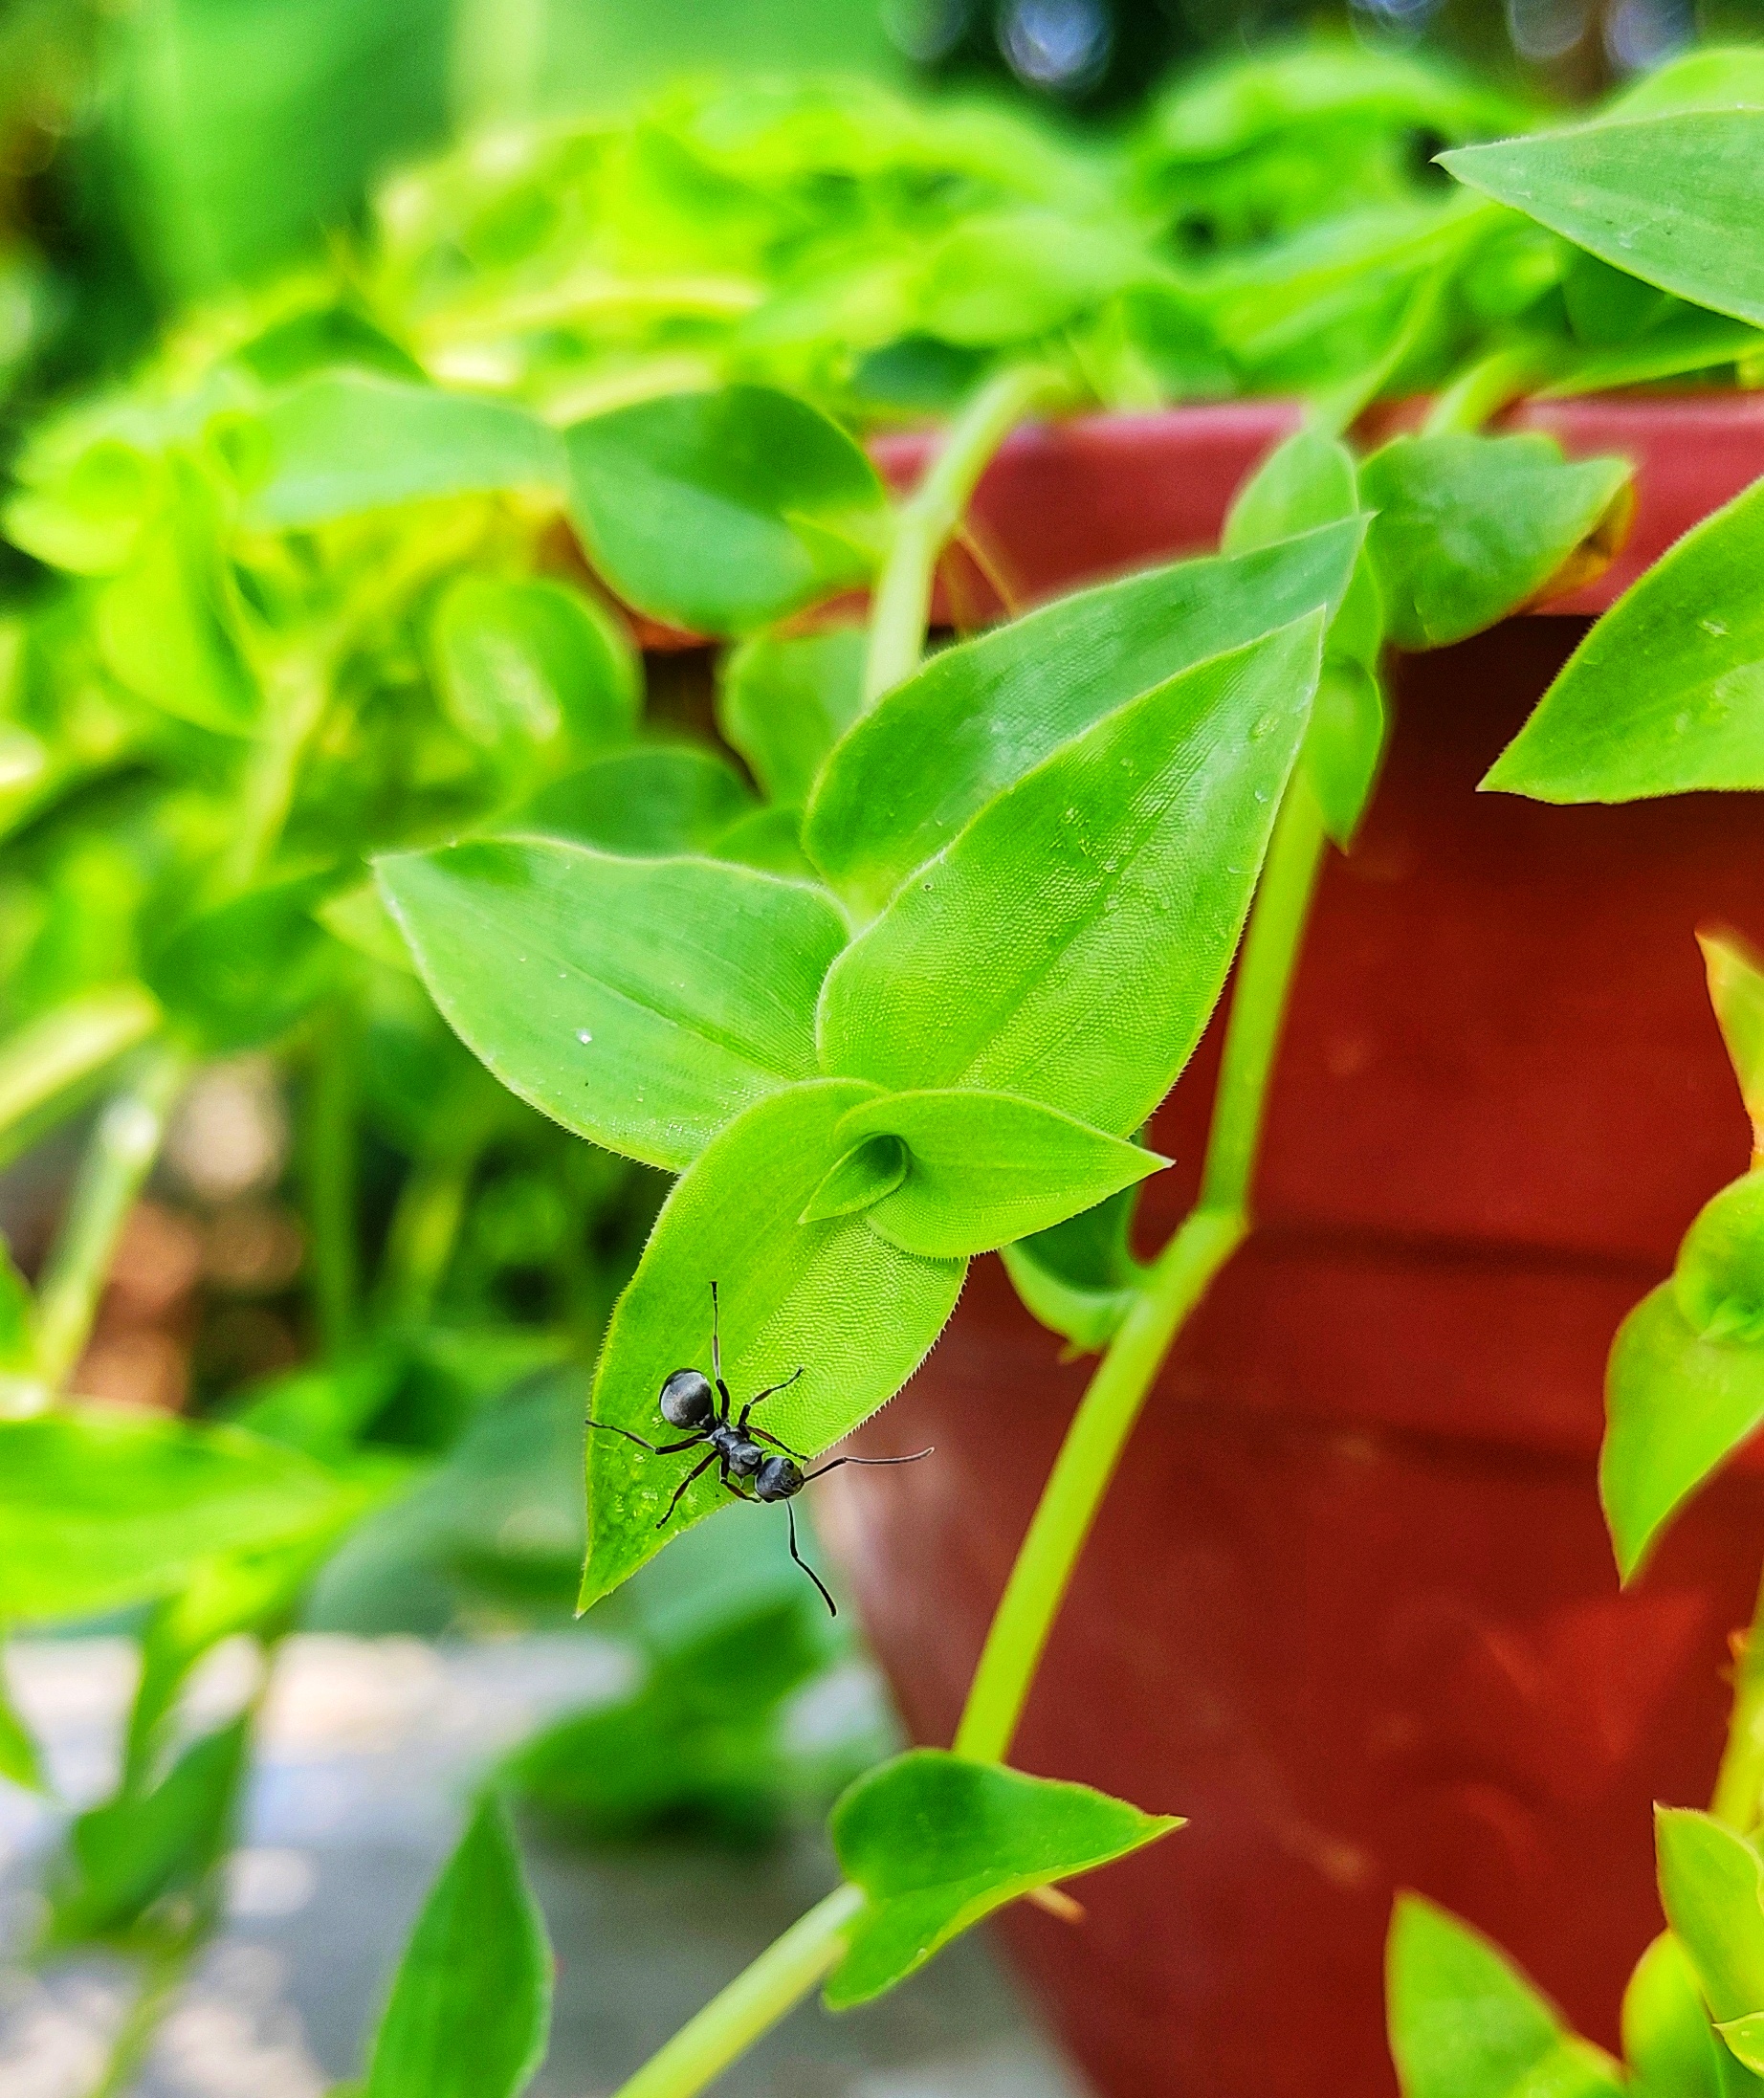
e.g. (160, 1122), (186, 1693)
(864, 365), (1055, 707)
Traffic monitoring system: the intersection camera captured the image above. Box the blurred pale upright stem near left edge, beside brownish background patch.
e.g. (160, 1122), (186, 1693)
(35, 1045), (188, 1405)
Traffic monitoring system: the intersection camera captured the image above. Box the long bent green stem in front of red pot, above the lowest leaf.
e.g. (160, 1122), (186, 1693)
(955, 779), (1324, 1760)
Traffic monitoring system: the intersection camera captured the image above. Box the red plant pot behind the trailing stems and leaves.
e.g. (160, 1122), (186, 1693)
(823, 401), (1764, 2098)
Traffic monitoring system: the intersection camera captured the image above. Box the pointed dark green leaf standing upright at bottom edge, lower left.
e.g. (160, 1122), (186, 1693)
(365, 1800), (552, 2098)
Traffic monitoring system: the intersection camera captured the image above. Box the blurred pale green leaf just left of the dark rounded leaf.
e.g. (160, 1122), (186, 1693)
(243, 371), (566, 531)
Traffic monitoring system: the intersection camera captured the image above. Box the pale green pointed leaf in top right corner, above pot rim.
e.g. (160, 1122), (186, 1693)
(1439, 109), (1764, 323)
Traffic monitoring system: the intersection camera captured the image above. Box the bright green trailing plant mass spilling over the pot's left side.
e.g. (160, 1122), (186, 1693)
(0, 33), (1760, 2098)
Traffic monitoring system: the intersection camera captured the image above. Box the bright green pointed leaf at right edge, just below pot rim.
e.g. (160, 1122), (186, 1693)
(1483, 480), (1764, 802)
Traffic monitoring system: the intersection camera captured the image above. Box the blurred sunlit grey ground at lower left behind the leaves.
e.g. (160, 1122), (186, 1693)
(0, 1634), (1082, 2098)
